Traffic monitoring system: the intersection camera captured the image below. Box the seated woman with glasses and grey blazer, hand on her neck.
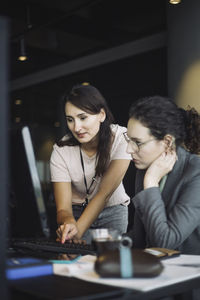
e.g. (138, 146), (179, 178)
(124, 96), (200, 254)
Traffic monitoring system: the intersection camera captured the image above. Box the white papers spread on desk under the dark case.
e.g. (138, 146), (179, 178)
(54, 255), (200, 291)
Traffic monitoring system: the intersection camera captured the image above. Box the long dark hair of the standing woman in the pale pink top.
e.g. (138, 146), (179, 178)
(57, 84), (114, 176)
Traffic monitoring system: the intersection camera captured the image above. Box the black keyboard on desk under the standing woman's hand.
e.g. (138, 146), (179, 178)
(11, 239), (96, 255)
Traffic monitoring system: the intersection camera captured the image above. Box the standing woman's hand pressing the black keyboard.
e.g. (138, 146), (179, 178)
(56, 223), (78, 244)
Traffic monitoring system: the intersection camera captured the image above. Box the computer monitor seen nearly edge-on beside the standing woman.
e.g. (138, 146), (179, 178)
(9, 126), (50, 238)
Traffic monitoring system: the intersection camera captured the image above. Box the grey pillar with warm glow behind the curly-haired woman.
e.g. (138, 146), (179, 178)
(167, 0), (200, 112)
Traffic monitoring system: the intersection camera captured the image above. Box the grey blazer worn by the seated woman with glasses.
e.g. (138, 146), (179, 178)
(129, 147), (200, 254)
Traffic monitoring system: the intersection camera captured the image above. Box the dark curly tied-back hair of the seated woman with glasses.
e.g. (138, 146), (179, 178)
(129, 96), (200, 154)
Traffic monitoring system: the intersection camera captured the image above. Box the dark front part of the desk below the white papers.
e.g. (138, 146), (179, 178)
(7, 275), (200, 300)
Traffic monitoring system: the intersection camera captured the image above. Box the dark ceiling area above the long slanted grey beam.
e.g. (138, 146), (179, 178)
(2, 0), (167, 80)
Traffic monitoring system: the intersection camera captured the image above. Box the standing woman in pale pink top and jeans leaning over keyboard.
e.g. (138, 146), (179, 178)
(50, 84), (131, 242)
